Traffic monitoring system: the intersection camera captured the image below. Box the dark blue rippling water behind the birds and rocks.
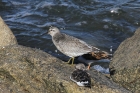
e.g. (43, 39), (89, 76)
(0, 0), (140, 59)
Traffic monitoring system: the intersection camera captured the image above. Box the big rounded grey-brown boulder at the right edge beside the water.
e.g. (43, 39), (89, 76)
(109, 28), (140, 93)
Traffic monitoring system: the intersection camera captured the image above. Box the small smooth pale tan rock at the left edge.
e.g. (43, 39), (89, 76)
(0, 17), (17, 48)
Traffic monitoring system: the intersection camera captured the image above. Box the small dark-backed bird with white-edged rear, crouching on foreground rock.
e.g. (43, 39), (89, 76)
(70, 64), (91, 88)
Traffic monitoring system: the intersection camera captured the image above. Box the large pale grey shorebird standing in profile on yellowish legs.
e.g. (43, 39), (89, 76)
(48, 26), (109, 68)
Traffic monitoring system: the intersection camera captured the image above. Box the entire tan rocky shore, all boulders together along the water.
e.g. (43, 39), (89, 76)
(0, 17), (137, 93)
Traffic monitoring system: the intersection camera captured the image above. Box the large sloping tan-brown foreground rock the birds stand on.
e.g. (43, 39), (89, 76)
(0, 16), (131, 93)
